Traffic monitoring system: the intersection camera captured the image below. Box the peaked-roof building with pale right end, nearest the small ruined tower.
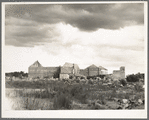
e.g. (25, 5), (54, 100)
(80, 64), (108, 76)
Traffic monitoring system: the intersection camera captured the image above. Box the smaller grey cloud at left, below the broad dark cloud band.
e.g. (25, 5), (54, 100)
(5, 23), (59, 47)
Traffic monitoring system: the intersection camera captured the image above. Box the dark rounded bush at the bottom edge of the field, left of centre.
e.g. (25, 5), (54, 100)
(53, 94), (71, 109)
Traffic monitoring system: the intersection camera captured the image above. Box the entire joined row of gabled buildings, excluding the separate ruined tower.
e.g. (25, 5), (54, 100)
(28, 61), (108, 79)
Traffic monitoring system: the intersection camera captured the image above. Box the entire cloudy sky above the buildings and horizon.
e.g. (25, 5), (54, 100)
(4, 3), (145, 74)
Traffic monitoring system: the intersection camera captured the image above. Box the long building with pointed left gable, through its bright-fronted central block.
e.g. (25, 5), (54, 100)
(28, 61), (80, 79)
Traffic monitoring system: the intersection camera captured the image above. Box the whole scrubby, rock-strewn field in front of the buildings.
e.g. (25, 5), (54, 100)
(6, 80), (145, 110)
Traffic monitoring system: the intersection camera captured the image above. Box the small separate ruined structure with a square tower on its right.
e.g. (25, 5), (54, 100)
(112, 66), (125, 80)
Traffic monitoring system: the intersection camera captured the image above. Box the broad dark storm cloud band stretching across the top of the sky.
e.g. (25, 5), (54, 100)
(6, 3), (144, 31)
